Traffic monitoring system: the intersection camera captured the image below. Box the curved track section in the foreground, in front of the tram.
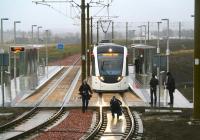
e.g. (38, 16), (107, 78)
(84, 94), (143, 140)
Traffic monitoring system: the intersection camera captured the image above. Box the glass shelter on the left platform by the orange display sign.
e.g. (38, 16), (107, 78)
(10, 45), (45, 98)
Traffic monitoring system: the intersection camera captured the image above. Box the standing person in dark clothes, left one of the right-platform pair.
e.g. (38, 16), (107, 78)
(150, 74), (158, 105)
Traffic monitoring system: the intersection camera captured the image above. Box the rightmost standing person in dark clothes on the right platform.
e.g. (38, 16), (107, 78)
(166, 72), (176, 105)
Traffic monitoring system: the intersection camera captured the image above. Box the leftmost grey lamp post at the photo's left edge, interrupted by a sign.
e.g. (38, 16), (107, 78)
(0, 18), (8, 107)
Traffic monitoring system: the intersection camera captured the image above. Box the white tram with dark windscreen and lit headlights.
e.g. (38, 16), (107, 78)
(92, 43), (128, 92)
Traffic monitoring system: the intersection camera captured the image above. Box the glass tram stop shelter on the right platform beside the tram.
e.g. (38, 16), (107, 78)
(131, 44), (156, 85)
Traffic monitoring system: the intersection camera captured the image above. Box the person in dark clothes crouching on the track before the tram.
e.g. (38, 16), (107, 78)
(110, 96), (122, 119)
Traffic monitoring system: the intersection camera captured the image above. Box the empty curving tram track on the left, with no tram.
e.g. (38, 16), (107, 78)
(0, 58), (80, 139)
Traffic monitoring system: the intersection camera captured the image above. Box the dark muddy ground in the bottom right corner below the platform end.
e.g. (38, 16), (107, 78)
(141, 113), (200, 140)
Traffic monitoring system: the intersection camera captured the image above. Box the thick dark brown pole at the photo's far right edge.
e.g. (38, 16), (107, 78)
(193, 0), (200, 120)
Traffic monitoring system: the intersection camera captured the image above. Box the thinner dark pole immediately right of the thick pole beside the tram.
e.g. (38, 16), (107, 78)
(87, 3), (90, 79)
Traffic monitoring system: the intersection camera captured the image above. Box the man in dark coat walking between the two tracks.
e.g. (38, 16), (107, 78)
(79, 80), (92, 113)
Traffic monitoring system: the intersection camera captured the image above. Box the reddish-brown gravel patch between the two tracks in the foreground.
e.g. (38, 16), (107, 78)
(35, 109), (93, 140)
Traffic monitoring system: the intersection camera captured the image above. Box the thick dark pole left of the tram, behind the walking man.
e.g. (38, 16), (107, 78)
(81, 0), (86, 82)
